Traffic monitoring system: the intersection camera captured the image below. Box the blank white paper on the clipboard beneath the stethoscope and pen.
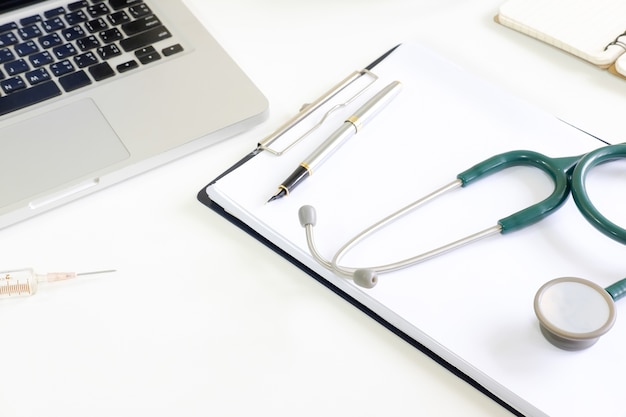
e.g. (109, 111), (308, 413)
(198, 44), (626, 417)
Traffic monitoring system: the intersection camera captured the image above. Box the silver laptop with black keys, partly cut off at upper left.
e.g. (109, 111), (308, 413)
(0, 0), (268, 228)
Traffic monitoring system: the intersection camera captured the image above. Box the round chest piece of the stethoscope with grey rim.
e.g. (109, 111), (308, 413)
(534, 278), (616, 350)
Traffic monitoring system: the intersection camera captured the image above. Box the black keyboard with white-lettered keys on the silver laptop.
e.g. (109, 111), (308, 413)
(0, 0), (183, 116)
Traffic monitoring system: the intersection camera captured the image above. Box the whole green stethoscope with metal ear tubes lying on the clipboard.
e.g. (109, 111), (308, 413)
(298, 144), (626, 350)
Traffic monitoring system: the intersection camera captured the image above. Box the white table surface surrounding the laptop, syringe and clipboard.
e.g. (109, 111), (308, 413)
(0, 0), (626, 417)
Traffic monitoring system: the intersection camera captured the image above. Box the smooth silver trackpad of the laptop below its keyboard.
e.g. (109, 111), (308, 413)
(0, 99), (129, 207)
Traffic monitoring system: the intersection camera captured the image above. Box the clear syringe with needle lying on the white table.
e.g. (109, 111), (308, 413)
(0, 268), (115, 298)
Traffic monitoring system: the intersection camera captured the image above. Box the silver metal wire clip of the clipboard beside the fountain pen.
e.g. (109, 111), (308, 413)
(257, 69), (378, 156)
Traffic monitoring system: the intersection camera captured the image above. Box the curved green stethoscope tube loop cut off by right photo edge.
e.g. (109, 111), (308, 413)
(571, 144), (626, 244)
